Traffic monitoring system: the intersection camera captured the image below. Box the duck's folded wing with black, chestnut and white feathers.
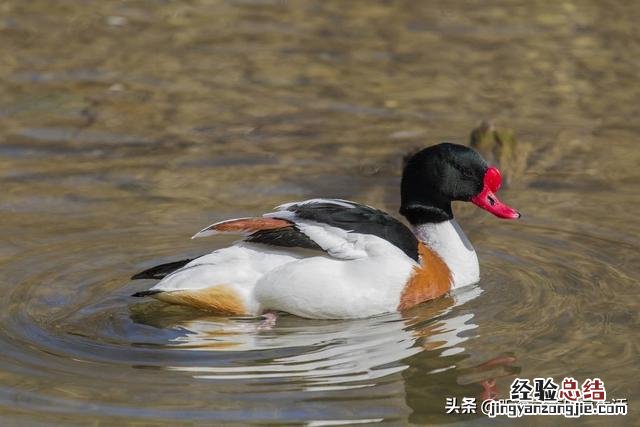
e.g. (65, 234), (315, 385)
(193, 199), (418, 260)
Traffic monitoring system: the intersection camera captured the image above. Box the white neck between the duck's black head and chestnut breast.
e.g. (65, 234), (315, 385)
(413, 219), (480, 288)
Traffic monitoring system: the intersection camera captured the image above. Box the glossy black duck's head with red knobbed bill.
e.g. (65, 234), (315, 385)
(400, 142), (520, 225)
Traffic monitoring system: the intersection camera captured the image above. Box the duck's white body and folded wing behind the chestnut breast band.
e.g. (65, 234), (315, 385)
(134, 199), (418, 318)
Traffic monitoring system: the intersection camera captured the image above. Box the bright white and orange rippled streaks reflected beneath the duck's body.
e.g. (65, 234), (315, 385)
(162, 286), (482, 391)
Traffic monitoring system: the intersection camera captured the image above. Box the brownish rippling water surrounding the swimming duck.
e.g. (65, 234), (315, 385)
(0, 0), (640, 425)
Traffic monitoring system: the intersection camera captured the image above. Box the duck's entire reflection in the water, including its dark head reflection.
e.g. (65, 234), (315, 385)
(132, 286), (515, 421)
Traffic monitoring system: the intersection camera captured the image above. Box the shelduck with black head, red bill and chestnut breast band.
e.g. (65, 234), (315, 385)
(132, 142), (521, 319)
